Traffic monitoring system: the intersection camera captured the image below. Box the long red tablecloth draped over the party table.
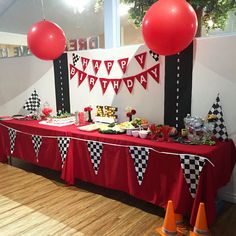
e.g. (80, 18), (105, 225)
(0, 120), (236, 225)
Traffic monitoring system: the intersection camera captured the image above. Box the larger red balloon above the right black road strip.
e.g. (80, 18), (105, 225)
(142, 0), (198, 55)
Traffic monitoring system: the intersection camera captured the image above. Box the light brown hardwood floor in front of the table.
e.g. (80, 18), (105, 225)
(0, 160), (236, 236)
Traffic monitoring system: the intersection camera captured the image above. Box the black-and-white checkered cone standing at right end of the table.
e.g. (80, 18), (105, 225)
(208, 94), (228, 141)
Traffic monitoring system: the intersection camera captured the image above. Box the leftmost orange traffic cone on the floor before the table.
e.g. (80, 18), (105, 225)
(156, 200), (181, 236)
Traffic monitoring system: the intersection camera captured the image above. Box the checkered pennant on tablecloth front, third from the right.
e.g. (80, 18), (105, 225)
(87, 140), (103, 175)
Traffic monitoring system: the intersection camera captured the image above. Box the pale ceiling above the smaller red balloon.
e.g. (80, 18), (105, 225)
(0, 0), (106, 39)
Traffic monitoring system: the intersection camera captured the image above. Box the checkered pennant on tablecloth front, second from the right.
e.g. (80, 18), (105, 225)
(129, 146), (149, 185)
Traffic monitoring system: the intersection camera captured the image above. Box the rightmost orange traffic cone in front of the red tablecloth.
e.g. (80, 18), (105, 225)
(190, 202), (210, 236)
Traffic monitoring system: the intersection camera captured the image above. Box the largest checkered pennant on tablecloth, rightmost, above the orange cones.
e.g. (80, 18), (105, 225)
(180, 154), (205, 198)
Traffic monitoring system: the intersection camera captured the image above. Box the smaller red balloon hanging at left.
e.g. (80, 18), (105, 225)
(27, 20), (66, 60)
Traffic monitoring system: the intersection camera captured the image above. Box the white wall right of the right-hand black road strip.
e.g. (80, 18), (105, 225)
(192, 35), (236, 203)
